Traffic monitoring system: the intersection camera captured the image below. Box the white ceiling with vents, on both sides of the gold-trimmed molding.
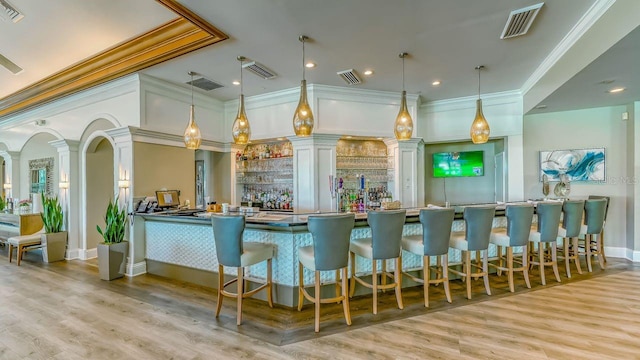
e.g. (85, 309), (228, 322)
(0, 0), (640, 116)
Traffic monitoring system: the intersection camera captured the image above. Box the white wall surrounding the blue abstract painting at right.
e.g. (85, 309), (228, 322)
(523, 106), (633, 250)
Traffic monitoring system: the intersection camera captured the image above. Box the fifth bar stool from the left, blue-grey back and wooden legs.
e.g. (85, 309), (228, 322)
(449, 206), (496, 300)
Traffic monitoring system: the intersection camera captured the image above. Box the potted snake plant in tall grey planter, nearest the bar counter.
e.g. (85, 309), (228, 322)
(96, 197), (129, 280)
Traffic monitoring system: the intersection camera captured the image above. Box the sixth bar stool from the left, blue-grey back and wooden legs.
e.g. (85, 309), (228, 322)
(489, 204), (533, 292)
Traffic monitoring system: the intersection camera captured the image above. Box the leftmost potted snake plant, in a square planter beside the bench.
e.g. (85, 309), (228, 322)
(40, 194), (67, 262)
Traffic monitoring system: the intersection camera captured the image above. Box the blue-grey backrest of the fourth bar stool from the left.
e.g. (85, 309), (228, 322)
(420, 208), (455, 256)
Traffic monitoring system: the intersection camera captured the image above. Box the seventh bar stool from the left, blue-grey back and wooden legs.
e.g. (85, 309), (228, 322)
(529, 202), (562, 285)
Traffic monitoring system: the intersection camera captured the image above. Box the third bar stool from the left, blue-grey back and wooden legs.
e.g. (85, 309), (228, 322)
(349, 210), (407, 314)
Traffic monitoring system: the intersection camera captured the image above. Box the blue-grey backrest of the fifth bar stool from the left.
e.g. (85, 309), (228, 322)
(463, 206), (496, 251)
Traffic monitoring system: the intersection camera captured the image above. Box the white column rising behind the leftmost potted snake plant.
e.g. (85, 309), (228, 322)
(49, 139), (81, 259)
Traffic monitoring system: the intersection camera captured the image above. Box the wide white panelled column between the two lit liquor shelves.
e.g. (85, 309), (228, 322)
(288, 134), (340, 212)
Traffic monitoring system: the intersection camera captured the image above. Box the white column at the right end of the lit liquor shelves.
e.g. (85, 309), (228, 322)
(384, 138), (424, 208)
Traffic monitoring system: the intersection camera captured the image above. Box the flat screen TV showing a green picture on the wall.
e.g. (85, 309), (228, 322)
(433, 151), (484, 178)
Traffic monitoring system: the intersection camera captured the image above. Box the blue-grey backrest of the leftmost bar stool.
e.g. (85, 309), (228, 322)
(211, 215), (245, 267)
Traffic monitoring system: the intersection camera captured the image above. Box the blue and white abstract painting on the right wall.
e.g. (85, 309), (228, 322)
(540, 148), (605, 181)
